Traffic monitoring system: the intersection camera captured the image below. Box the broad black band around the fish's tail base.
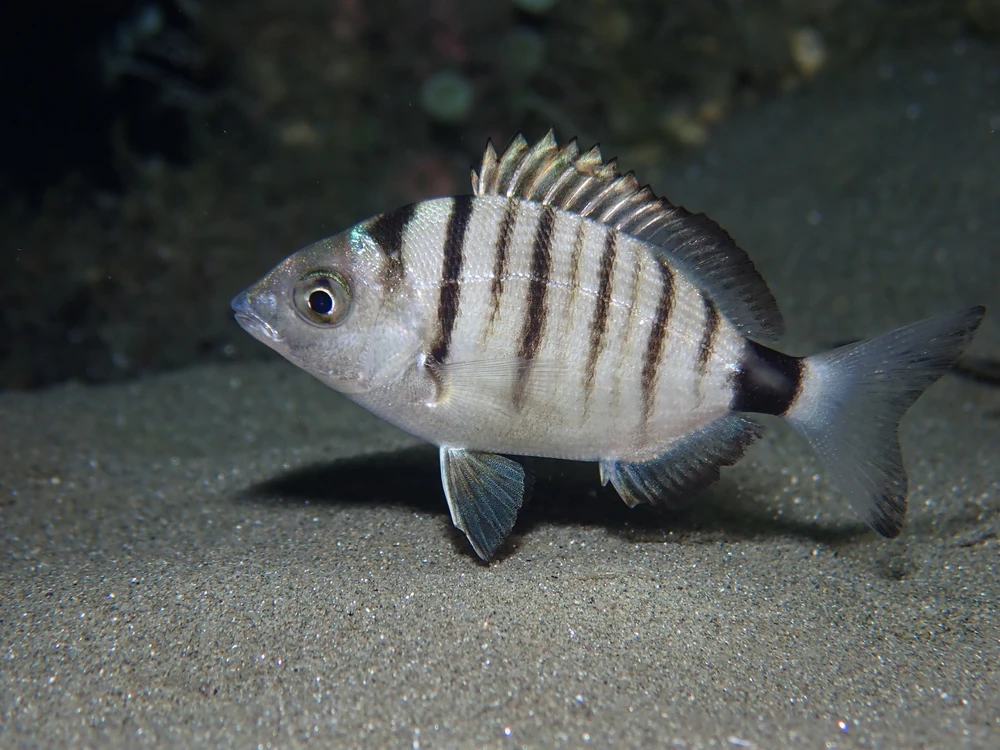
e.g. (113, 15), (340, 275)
(730, 340), (802, 416)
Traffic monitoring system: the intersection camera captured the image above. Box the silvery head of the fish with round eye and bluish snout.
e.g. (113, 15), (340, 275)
(232, 225), (420, 394)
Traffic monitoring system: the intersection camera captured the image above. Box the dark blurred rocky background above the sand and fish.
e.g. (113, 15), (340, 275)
(0, 0), (1000, 389)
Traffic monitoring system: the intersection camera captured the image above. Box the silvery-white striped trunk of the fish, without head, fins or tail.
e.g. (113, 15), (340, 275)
(342, 196), (744, 461)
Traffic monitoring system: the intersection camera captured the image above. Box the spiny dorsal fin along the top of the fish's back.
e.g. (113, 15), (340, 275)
(472, 130), (784, 339)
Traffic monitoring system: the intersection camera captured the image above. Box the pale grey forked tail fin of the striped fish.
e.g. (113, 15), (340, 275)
(785, 307), (986, 538)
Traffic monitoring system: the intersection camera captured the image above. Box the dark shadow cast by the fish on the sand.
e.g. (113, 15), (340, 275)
(241, 446), (872, 557)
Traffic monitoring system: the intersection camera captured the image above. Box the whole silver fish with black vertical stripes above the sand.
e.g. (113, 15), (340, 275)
(232, 131), (985, 561)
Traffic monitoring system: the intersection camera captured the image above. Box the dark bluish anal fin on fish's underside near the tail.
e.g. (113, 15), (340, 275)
(600, 414), (761, 508)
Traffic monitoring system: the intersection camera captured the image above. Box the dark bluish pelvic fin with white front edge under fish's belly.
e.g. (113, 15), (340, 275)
(441, 446), (528, 560)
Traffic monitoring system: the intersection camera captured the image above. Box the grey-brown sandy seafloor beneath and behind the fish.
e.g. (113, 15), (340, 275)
(0, 44), (1000, 748)
